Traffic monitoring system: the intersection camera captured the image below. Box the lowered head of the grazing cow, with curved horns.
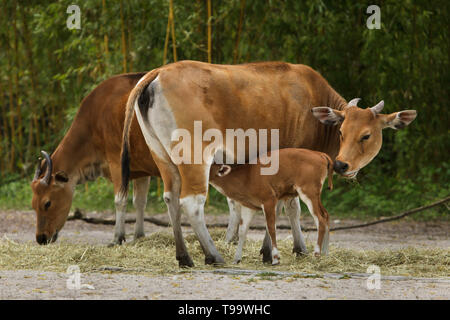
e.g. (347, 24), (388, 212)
(31, 151), (73, 244)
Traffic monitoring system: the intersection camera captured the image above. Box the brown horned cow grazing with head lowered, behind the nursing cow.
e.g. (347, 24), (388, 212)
(31, 73), (159, 244)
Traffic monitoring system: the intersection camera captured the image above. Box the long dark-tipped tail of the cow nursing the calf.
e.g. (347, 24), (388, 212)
(119, 70), (159, 197)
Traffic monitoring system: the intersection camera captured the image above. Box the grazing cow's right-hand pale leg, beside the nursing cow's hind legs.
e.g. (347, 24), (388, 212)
(133, 177), (150, 240)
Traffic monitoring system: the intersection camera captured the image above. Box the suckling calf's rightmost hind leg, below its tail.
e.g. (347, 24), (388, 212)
(297, 188), (329, 256)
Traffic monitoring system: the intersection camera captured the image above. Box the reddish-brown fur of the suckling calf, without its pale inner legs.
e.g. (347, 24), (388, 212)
(210, 148), (333, 256)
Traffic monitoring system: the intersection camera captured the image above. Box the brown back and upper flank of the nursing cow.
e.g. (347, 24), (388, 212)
(158, 61), (344, 156)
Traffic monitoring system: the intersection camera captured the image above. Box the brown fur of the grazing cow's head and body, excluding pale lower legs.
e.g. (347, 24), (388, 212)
(31, 73), (159, 239)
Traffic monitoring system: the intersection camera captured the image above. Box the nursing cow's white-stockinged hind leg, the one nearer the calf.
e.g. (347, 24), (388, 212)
(178, 163), (225, 264)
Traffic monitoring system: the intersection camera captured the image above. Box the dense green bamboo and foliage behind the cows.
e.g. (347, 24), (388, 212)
(0, 0), (450, 216)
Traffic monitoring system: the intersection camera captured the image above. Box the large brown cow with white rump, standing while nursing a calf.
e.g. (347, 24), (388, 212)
(122, 61), (416, 265)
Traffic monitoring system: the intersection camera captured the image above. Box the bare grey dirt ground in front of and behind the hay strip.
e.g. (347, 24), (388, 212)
(0, 211), (450, 300)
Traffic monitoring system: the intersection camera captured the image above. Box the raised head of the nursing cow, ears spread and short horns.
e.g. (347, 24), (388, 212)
(311, 98), (417, 178)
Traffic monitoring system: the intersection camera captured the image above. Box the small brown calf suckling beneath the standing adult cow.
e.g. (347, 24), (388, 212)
(210, 148), (333, 265)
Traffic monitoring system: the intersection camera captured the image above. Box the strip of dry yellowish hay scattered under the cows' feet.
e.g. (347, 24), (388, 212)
(0, 229), (450, 277)
